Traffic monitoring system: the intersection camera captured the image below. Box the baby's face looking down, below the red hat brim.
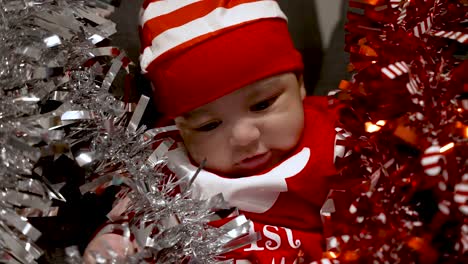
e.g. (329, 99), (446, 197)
(175, 73), (305, 177)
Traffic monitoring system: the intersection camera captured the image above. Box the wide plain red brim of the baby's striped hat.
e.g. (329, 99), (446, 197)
(146, 19), (303, 118)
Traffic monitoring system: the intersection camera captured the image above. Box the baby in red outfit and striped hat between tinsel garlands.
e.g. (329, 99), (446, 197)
(86, 0), (337, 264)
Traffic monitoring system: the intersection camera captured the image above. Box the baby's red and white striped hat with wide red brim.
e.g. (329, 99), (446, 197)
(140, 0), (303, 118)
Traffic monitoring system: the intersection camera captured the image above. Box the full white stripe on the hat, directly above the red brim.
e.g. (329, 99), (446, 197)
(140, 0), (287, 73)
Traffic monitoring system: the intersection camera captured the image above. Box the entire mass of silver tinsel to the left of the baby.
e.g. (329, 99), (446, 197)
(0, 0), (254, 263)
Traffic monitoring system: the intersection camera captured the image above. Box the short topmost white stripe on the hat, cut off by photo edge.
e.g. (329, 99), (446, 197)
(140, 0), (201, 26)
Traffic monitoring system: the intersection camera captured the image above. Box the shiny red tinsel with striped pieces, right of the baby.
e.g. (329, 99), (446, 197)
(317, 0), (468, 263)
